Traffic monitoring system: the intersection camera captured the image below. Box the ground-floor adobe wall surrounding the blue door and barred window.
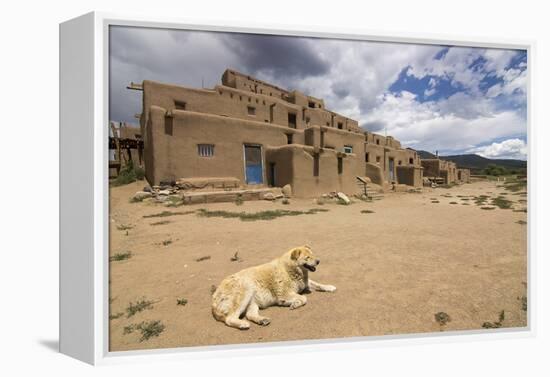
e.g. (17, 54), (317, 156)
(146, 106), (287, 184)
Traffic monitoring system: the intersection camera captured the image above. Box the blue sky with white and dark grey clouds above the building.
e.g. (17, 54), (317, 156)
(110, 27), (527, 159)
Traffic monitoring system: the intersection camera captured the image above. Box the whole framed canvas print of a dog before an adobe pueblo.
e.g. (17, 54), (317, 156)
(60, 13), (532, 363)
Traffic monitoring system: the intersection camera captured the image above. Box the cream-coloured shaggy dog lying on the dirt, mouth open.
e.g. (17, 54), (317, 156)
(212, 246), (336, 330)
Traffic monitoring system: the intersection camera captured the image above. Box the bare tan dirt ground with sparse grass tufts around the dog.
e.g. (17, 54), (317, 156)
(110, 181), (527, 351)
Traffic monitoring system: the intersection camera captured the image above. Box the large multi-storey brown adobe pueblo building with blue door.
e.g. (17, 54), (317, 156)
(133, 70), (462, 201)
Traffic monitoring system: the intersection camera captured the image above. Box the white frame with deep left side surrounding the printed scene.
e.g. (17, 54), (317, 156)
(60, 12), (537, 364)
